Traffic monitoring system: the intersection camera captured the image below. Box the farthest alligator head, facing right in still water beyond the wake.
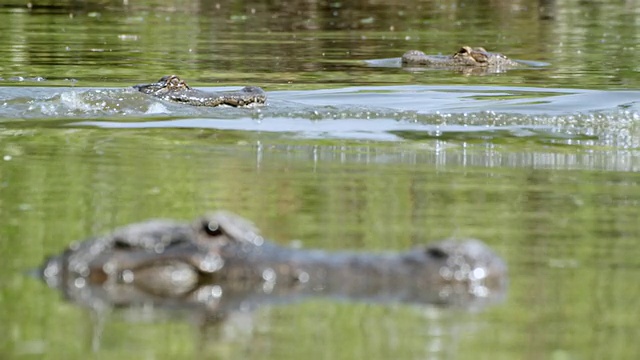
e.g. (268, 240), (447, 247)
(402, 46), (520, 72)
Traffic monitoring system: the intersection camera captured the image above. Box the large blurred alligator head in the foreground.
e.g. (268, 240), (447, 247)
(40, 212), (507, 318)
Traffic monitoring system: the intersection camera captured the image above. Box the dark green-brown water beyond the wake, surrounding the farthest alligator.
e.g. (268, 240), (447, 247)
(0, 0), (637, 90)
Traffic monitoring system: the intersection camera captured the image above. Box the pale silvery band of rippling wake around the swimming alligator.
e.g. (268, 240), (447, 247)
(0, 86), (640, 149)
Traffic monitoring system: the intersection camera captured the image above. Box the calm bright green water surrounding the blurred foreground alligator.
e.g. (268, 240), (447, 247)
(0, 128), (640, 358)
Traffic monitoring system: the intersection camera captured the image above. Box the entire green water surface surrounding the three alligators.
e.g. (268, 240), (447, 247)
(0, 0), (640, 359)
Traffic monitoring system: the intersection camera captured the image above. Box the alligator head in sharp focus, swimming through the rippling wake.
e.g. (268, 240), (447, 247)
(133, 75), (267, 106)
